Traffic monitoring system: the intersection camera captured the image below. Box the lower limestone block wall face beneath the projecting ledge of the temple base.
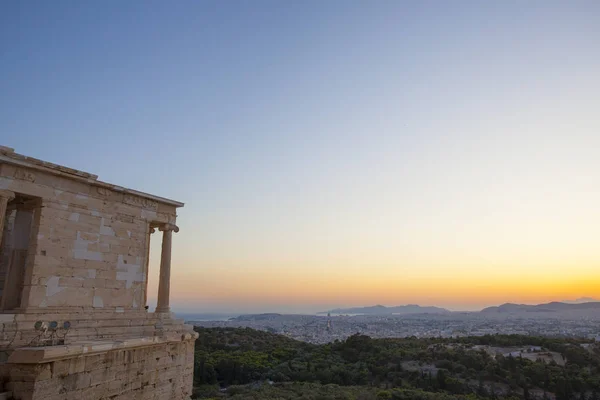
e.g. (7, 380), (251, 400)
(7, 341), (194, 400)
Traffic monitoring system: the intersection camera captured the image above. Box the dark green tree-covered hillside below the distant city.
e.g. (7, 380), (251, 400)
(194, 328), (600, 400)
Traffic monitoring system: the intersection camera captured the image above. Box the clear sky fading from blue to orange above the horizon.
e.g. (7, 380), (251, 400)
(0, 0), (600, 312)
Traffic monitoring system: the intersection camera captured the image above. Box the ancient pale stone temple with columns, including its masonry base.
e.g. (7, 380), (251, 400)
(0, 147), (197, 400)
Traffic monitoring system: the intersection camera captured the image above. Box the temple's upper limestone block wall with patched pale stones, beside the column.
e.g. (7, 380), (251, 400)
(0, 160), (176, 311)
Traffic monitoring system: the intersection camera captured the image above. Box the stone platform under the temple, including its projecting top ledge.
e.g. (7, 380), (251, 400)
(3, 333), (195, 400)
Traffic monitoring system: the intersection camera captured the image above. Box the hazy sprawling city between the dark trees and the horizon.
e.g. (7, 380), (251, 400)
(185, 303), (600, 344)
